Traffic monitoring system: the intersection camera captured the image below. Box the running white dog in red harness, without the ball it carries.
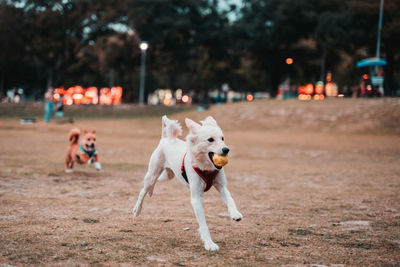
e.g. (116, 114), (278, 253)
(133, 116), (243, 250)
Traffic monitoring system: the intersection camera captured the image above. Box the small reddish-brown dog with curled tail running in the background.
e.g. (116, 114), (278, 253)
(65, 128), (101, 173)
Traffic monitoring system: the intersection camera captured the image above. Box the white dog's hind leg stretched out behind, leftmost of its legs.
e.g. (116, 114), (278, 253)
(133, 148), (165, 217)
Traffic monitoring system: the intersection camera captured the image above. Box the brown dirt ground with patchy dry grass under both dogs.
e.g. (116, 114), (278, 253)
(0, 99), (400, 267)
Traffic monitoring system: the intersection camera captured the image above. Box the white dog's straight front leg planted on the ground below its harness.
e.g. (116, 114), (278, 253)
(190, 182), (219, 251)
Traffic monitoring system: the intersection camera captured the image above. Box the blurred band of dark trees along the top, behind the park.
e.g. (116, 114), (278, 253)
(0, 0), (400, 102)
